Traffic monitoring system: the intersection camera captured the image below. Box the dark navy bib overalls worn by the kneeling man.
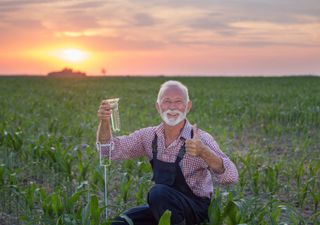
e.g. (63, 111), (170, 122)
(112, 132), (210, 225)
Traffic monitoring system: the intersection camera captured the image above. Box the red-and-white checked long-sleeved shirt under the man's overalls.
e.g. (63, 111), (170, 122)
(101, 121), (238, 198)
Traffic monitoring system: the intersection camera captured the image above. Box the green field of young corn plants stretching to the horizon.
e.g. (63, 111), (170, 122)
(0, 77), (320, 225)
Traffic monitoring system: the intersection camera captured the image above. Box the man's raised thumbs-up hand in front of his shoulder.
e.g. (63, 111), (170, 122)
(185, 124), (205, 156)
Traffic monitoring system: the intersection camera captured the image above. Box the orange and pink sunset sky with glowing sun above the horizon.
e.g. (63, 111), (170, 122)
(0, 0), (320, 75)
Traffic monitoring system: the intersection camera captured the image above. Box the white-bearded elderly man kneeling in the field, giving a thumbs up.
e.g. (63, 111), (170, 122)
(97, 81), (238, 225)
